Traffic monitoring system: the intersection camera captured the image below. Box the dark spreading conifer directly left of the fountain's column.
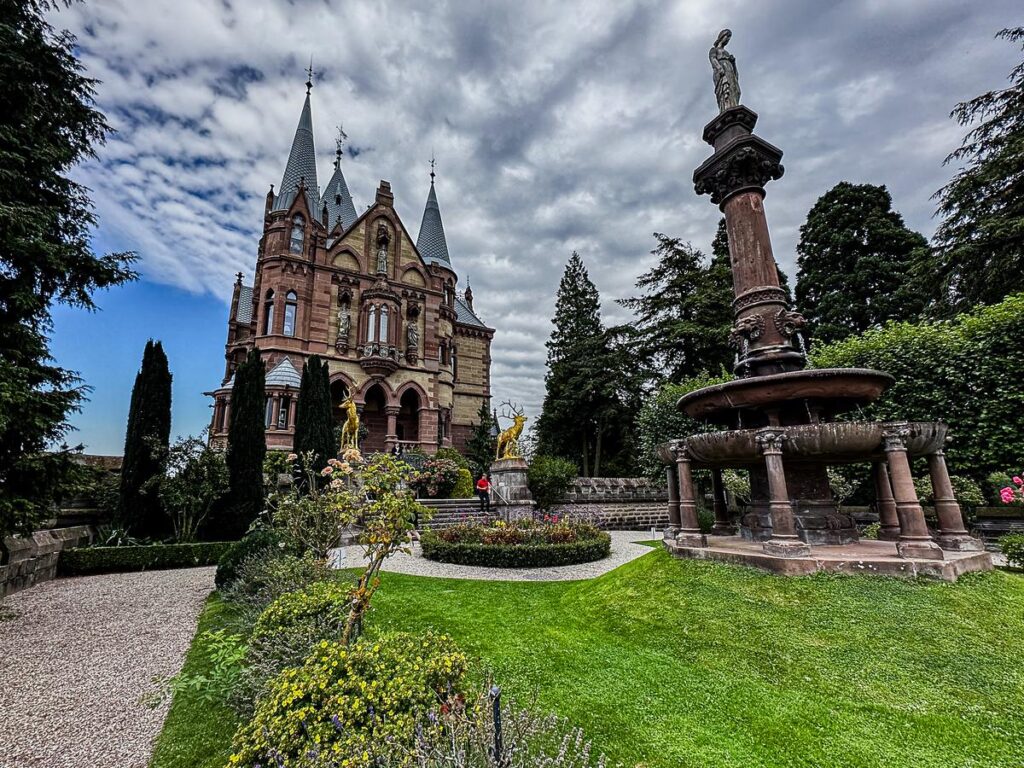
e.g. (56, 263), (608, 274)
(618, 228), (732, 381)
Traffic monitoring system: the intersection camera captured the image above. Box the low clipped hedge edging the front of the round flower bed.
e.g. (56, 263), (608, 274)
(420, 530), (611, 568)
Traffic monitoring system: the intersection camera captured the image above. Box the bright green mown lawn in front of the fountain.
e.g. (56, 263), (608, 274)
(154, 551), (1024, 768)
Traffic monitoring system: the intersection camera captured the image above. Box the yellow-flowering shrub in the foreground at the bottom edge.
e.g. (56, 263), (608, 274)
(228, 633), (467, 768)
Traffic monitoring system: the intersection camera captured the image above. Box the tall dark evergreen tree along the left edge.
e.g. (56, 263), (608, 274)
(0, 0), (134, 560)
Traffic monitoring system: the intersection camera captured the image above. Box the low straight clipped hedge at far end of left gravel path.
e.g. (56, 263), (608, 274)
(58, 542), (232, 575)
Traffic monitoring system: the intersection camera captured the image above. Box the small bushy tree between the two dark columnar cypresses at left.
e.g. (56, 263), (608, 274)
(154, 435), (227, 542)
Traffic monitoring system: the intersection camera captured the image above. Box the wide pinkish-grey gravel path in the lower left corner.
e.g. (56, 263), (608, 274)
(0, 568), (215, 768)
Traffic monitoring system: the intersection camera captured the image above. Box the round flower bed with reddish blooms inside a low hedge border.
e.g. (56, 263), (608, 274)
(420, 520), (611, 568)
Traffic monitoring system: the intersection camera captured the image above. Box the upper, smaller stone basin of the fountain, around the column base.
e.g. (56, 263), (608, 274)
(677, 368), (895, 424)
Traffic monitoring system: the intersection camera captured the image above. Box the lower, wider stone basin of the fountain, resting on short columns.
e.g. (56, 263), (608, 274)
(675, 421), (947, 467)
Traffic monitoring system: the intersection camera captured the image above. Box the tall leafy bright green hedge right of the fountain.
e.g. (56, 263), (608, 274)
(811, 293), (1024, 483)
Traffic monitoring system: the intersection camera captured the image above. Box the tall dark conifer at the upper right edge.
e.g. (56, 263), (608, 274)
(922, 27), (1024, 313)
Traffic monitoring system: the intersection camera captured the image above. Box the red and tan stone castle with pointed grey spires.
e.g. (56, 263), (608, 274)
(207, 82), (495, 453)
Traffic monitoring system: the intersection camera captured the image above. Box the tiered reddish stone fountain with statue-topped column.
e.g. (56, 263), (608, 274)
(660, 30), (991, 579)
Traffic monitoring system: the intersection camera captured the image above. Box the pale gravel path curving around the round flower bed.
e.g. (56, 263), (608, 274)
(336, 530), (651, 582)
